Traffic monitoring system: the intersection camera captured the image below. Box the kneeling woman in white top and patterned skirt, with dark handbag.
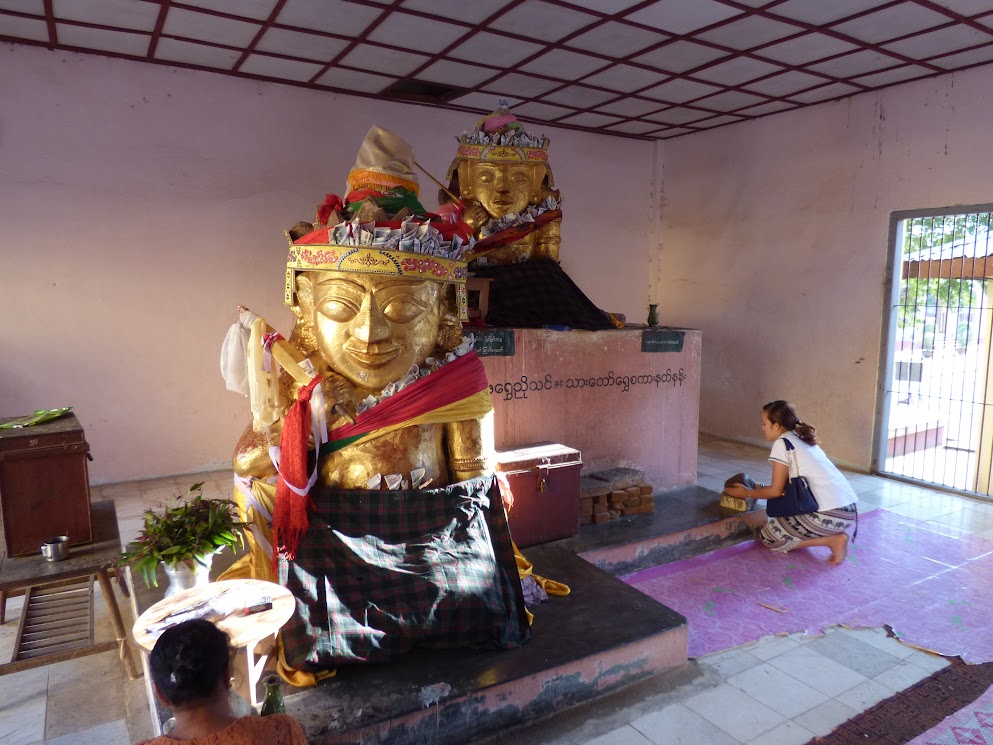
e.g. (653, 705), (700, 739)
(727, 401), (858, 564)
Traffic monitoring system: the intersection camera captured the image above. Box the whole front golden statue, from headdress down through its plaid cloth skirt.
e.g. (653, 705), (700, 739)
(222, 127), (568, 685)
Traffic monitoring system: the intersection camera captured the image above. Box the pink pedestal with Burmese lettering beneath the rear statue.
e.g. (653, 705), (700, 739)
(483, 329), (701, 489)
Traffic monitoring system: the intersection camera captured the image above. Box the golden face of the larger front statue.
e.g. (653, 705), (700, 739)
(298, 272), (444, 391)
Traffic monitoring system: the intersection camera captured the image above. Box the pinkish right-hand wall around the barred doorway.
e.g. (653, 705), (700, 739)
(659, 65), (993, 469)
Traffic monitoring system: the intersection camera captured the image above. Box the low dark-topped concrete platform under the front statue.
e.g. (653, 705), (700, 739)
(286, 486), (764, 745)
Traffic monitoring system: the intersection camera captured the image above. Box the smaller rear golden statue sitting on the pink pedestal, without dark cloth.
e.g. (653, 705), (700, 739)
(441, 100), (562, 265)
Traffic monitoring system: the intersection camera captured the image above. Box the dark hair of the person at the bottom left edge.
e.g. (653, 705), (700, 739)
(148, 620), (230, 707)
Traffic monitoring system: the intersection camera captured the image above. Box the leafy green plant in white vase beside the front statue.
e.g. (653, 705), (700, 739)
(117, 482), (248, 597)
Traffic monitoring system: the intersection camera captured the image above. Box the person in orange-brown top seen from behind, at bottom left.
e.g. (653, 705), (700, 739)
(141, 620), (307, 745)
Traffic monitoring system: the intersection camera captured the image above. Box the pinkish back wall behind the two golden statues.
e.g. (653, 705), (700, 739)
(0, 45), (654, 483)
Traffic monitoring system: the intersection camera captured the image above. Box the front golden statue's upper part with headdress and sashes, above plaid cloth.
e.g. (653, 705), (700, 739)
(222, 127), (494, 600)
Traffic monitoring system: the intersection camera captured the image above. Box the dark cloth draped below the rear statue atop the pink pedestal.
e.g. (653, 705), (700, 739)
(472, 259), (614, 331)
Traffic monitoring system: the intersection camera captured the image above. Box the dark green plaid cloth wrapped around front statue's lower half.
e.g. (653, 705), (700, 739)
(279, 477), (530, 671)
